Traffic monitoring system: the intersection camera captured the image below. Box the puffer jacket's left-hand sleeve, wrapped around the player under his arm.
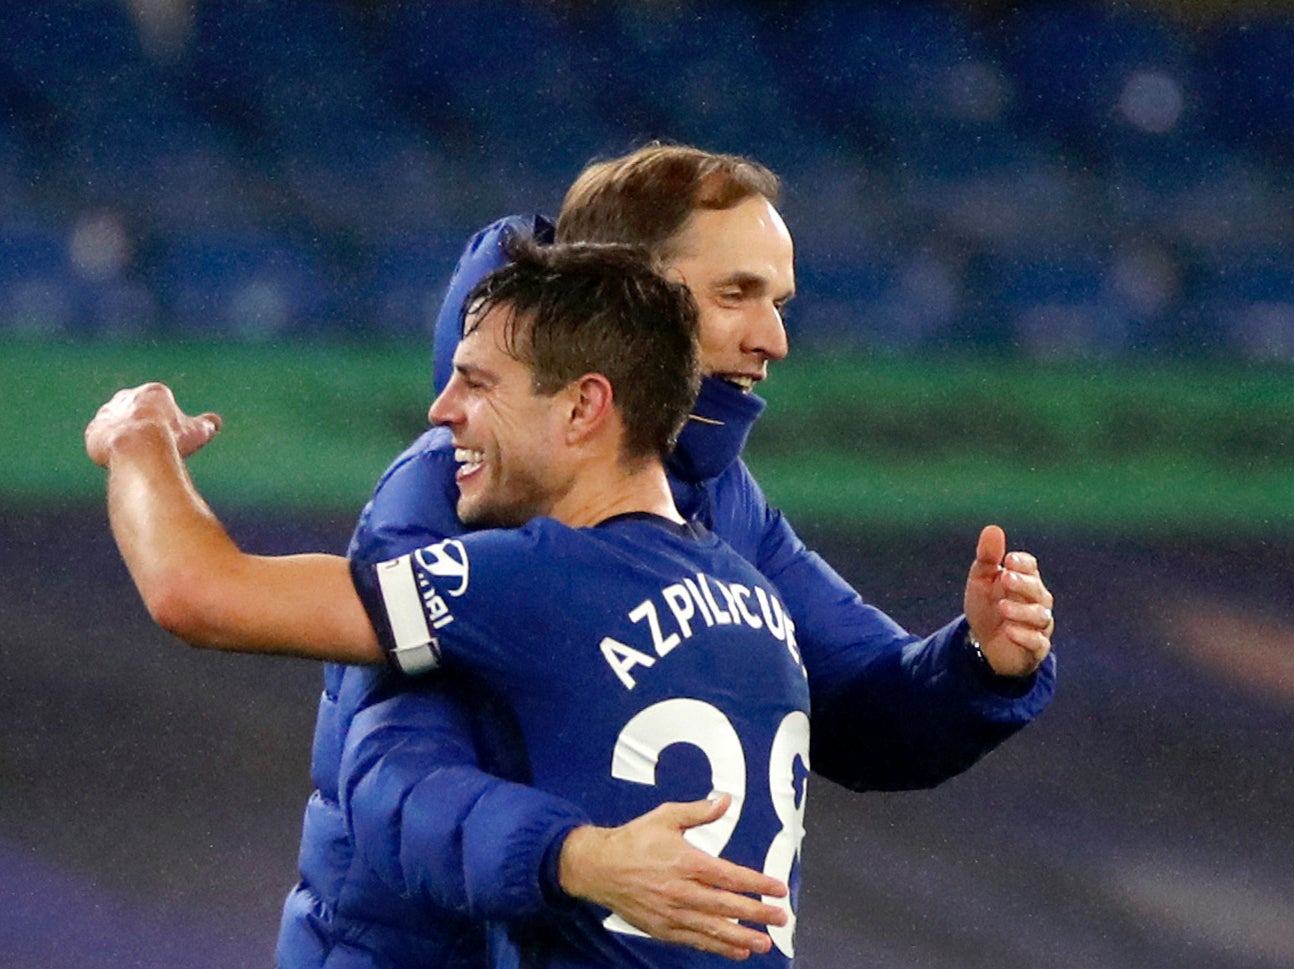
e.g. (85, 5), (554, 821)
(338, 445), (587, 920)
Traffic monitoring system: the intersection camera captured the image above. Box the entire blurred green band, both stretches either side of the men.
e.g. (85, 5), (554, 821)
(0, 343), (1294, 533)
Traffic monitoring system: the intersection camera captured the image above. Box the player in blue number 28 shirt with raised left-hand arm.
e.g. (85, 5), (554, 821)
(85, 246), (809, 969)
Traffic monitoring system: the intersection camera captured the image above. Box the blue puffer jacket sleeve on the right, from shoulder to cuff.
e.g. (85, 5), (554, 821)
(717, 462), (1056, 790)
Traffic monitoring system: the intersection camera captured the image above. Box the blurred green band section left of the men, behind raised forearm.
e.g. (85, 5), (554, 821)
(8, 343), (430, 510)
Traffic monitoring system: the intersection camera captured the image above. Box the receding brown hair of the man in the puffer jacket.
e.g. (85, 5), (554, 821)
(556, 142), (782, 264)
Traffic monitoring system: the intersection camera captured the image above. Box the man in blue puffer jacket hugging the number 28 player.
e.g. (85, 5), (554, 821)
(86, 146), (1053, 966)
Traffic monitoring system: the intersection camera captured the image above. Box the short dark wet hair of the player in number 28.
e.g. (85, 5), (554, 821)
(463, 242), (701, 461)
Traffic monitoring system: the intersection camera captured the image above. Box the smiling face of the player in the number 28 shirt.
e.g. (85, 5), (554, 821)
(427, 305), (568, 527)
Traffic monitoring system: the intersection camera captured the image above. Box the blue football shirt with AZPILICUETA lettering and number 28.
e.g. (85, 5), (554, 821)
(360, 515), (809, 969)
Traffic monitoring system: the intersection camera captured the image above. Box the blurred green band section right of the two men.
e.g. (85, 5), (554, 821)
(748, 360), (1294, 534)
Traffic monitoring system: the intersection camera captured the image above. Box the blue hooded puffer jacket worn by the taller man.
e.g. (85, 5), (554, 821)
(278, 217), (1055, 969)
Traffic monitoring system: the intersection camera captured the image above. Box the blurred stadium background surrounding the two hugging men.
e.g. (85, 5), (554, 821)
(0, 0), (1294, 969)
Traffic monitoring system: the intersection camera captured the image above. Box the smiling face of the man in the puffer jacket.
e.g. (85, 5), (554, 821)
(663, 195), (796, 389)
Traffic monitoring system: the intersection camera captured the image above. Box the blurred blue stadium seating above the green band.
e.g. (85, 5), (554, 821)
(0, 0), (1294, 352)
